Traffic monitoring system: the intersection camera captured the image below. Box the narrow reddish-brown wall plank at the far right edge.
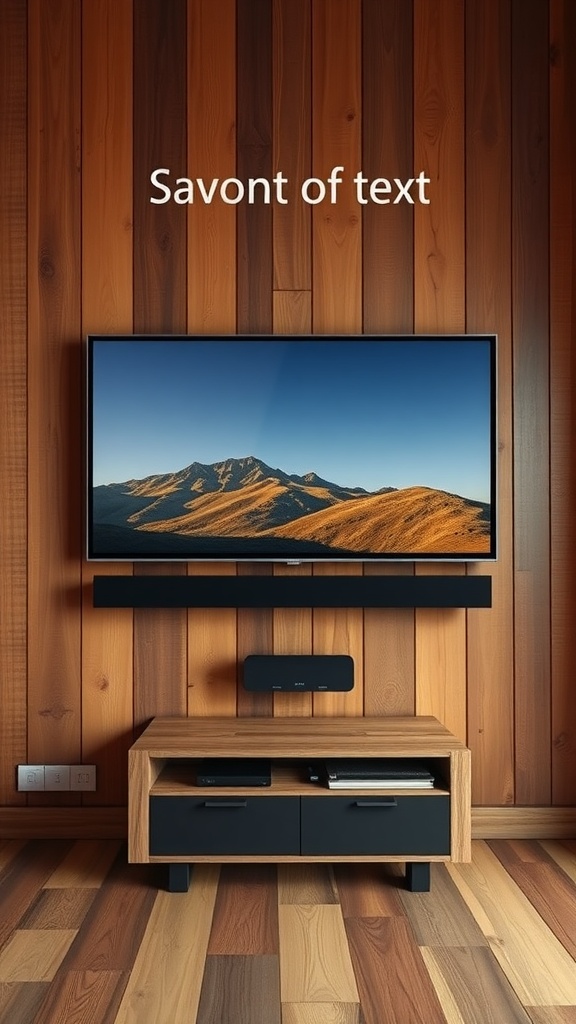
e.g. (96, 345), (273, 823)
(550, 0), (576, 804)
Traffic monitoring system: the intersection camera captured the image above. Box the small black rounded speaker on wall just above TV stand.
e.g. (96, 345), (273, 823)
(244, 654), (354, 693)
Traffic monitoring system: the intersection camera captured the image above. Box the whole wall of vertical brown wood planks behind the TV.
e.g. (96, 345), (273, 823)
(0, 0), (576, 813)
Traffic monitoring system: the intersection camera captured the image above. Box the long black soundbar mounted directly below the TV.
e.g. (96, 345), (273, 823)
(93, 575), (492, 608)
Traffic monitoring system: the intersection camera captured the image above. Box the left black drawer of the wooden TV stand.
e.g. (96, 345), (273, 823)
(150, 796), (300, 856)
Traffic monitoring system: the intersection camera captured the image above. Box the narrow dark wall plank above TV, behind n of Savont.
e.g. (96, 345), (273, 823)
(237, 0), (273, 334)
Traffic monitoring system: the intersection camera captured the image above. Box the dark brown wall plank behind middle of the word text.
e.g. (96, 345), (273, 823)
(362, 0), (415, 715)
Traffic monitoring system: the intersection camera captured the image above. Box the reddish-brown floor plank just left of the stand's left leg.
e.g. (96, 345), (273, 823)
(52, 852), (158, 972)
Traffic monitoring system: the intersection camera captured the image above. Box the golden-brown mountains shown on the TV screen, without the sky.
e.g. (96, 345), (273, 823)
(92, 456), (490, 559)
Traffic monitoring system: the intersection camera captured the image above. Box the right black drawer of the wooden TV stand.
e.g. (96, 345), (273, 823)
(301, 795), (450, 857)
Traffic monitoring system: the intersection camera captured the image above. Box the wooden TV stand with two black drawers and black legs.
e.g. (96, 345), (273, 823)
(128, 716), (470, 892)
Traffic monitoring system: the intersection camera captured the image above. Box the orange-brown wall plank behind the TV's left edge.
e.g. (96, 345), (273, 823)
(82, 0), (133, 805)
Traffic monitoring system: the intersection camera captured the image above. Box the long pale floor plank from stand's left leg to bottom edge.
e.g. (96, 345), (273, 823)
(116, 864), (219, 1024)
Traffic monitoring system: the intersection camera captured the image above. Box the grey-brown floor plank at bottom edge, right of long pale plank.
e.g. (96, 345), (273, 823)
(194, 955), (281, 1024)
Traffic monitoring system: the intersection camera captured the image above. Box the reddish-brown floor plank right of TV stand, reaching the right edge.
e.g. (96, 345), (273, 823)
(489, 841), (576, 969)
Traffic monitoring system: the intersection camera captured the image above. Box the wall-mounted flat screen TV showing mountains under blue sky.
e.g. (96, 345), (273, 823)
(87, 335), (497, 563)
